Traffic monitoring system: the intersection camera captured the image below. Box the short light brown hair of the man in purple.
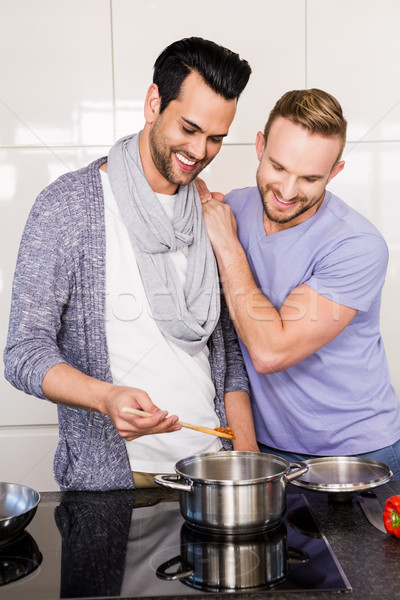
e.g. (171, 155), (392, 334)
(264, 88), (347, 160)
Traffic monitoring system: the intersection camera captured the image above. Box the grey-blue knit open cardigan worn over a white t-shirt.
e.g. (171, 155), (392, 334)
(4, 158), (248, 491)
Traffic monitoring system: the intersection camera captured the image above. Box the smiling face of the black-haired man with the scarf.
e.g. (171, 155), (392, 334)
(139, 72), (236, 194)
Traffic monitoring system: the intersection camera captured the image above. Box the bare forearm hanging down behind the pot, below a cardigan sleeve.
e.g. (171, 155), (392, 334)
(225, 392), (258, 452)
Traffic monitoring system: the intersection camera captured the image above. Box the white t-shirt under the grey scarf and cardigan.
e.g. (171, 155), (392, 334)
(100, 170), (221, 473)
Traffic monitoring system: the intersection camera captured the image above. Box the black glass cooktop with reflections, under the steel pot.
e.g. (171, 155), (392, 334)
(0, 492), (351, 600)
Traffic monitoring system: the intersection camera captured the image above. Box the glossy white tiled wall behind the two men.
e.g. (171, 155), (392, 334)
(0, 0), (400, 490)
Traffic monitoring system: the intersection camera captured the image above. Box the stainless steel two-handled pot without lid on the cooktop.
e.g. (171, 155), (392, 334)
(154, 452), (308, 533)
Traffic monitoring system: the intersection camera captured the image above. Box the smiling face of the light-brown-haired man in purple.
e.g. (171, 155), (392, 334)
(256, 117), (344, 235)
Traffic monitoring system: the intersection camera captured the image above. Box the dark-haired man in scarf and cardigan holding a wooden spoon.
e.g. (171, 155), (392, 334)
(4, 38), (257, 490)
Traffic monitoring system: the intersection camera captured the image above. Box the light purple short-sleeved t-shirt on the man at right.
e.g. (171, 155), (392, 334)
(226, 188), (400, 456)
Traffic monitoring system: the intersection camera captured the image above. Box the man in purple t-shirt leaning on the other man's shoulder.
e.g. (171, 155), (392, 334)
(203, 89), (400, 479)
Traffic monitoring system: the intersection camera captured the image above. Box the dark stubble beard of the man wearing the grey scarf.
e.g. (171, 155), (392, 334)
(149, 118), (211, 185)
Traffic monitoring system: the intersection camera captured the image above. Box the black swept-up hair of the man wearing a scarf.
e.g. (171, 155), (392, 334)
(153, 37), (251, 112)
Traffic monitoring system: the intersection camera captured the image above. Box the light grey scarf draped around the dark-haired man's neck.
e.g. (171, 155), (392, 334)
(107, 134), (220, 356)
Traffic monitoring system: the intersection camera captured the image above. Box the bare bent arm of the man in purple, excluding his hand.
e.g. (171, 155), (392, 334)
(218, 238), (357, 374)
